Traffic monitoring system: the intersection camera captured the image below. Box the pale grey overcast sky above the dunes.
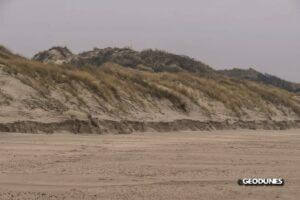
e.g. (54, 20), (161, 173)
(0, 0), (300, 82)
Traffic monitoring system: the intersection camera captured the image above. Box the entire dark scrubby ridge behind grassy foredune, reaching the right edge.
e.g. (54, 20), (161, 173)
(33, 47), (300, 92)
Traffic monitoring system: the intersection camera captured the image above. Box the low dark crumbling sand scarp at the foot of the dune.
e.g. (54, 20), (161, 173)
(0, 119), (300, 134)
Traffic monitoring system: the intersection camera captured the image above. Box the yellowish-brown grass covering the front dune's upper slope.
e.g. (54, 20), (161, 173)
(0, 45), (300, 116)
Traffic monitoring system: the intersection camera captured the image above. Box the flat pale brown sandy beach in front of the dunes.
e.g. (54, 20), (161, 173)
(0, 130), (300, 200)
